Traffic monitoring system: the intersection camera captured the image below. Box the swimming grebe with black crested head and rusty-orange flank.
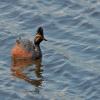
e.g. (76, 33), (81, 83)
(11, 27), (47, 59)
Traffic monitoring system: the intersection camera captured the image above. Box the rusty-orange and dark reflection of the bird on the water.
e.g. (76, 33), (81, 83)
(11, 59), (43, 87)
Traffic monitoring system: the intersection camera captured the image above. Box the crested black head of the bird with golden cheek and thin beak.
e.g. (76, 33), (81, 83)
(34, 27), (47, 44)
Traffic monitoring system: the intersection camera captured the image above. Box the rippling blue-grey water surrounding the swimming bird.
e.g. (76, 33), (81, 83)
(0, 0), (100, 100)
